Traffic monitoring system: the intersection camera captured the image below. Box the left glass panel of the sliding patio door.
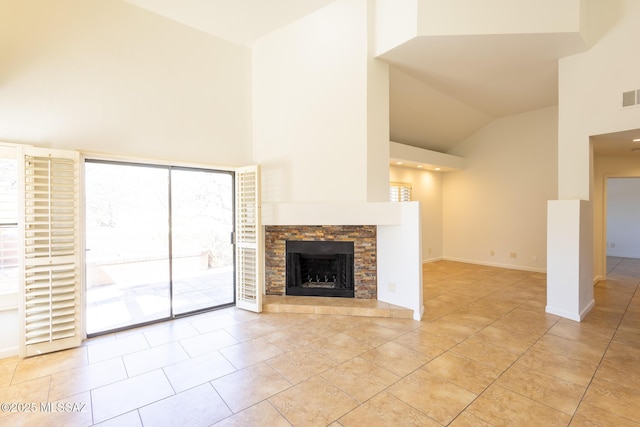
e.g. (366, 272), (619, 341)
(85, 162), (171, 334)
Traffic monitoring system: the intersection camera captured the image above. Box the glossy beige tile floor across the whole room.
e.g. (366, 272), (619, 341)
(0, 259), (640, 427)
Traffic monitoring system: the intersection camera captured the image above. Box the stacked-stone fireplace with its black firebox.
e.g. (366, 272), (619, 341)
(265, 225), (377, 299)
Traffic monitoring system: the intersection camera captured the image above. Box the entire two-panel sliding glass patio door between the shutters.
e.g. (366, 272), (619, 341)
(84, 160), (235, 335)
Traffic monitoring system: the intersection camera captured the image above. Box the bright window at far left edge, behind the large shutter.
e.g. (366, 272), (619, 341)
(0, 147), (18, 293)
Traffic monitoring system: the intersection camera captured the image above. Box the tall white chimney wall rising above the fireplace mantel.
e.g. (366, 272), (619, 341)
(253, 0), (370, 203)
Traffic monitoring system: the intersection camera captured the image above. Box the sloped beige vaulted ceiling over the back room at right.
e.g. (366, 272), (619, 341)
(382, 34), (584, 152)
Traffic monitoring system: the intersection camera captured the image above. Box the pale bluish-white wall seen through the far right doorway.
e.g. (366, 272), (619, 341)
(607, 178), (640, 258)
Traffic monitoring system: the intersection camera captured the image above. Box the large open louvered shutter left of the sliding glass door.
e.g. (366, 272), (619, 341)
(21, 148), (82, 357)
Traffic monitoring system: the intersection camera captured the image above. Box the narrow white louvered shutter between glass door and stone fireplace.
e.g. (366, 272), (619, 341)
(236, 166), (263, 313)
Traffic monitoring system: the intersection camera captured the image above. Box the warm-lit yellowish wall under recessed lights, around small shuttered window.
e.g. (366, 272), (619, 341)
(389, 166), (443, 262)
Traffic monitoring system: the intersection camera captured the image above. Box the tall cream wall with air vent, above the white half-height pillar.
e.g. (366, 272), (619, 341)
(558, 0), (640, 200)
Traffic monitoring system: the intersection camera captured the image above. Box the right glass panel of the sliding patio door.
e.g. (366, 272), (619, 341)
(171, 169), (234, 315)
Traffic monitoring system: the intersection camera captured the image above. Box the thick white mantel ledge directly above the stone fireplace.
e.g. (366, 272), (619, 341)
(262, 202), (401, 225)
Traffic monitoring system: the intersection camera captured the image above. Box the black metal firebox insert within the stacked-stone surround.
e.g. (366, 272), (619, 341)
(286, 240), (354, 298)
